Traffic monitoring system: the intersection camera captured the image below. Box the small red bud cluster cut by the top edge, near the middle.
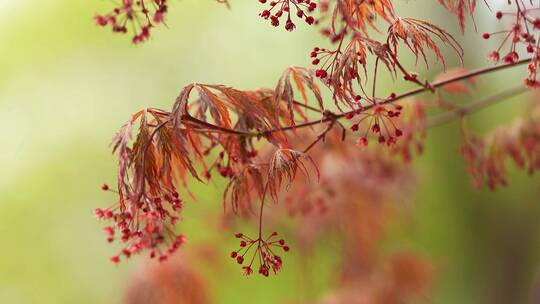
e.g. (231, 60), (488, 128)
(259, 0), (317, 31)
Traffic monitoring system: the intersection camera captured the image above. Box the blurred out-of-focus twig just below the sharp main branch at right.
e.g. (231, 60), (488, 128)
(426, 85), (528, 128)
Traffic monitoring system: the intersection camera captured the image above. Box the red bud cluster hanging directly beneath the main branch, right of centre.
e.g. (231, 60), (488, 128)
(346, 104), (403, 146)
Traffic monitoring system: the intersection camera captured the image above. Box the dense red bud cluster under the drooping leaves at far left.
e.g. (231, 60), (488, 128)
(95, 184), (185, 264)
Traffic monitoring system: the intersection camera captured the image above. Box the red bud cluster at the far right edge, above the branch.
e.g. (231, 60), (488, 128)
(482, 2), (540, 88)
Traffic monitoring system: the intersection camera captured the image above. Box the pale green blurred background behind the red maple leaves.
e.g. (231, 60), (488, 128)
(0, 0), (540, 304)
